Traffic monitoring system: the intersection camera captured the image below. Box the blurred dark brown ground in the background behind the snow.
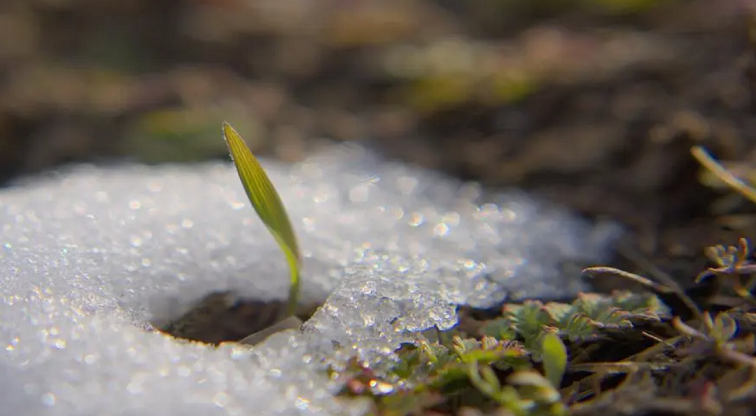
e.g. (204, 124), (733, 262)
(0, 0), (756, 280)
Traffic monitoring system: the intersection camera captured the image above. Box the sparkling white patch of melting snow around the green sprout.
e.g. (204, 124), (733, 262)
(0, 147), (615, 416)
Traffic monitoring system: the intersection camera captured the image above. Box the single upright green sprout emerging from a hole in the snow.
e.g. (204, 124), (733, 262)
(223, 122), (301, 316)
